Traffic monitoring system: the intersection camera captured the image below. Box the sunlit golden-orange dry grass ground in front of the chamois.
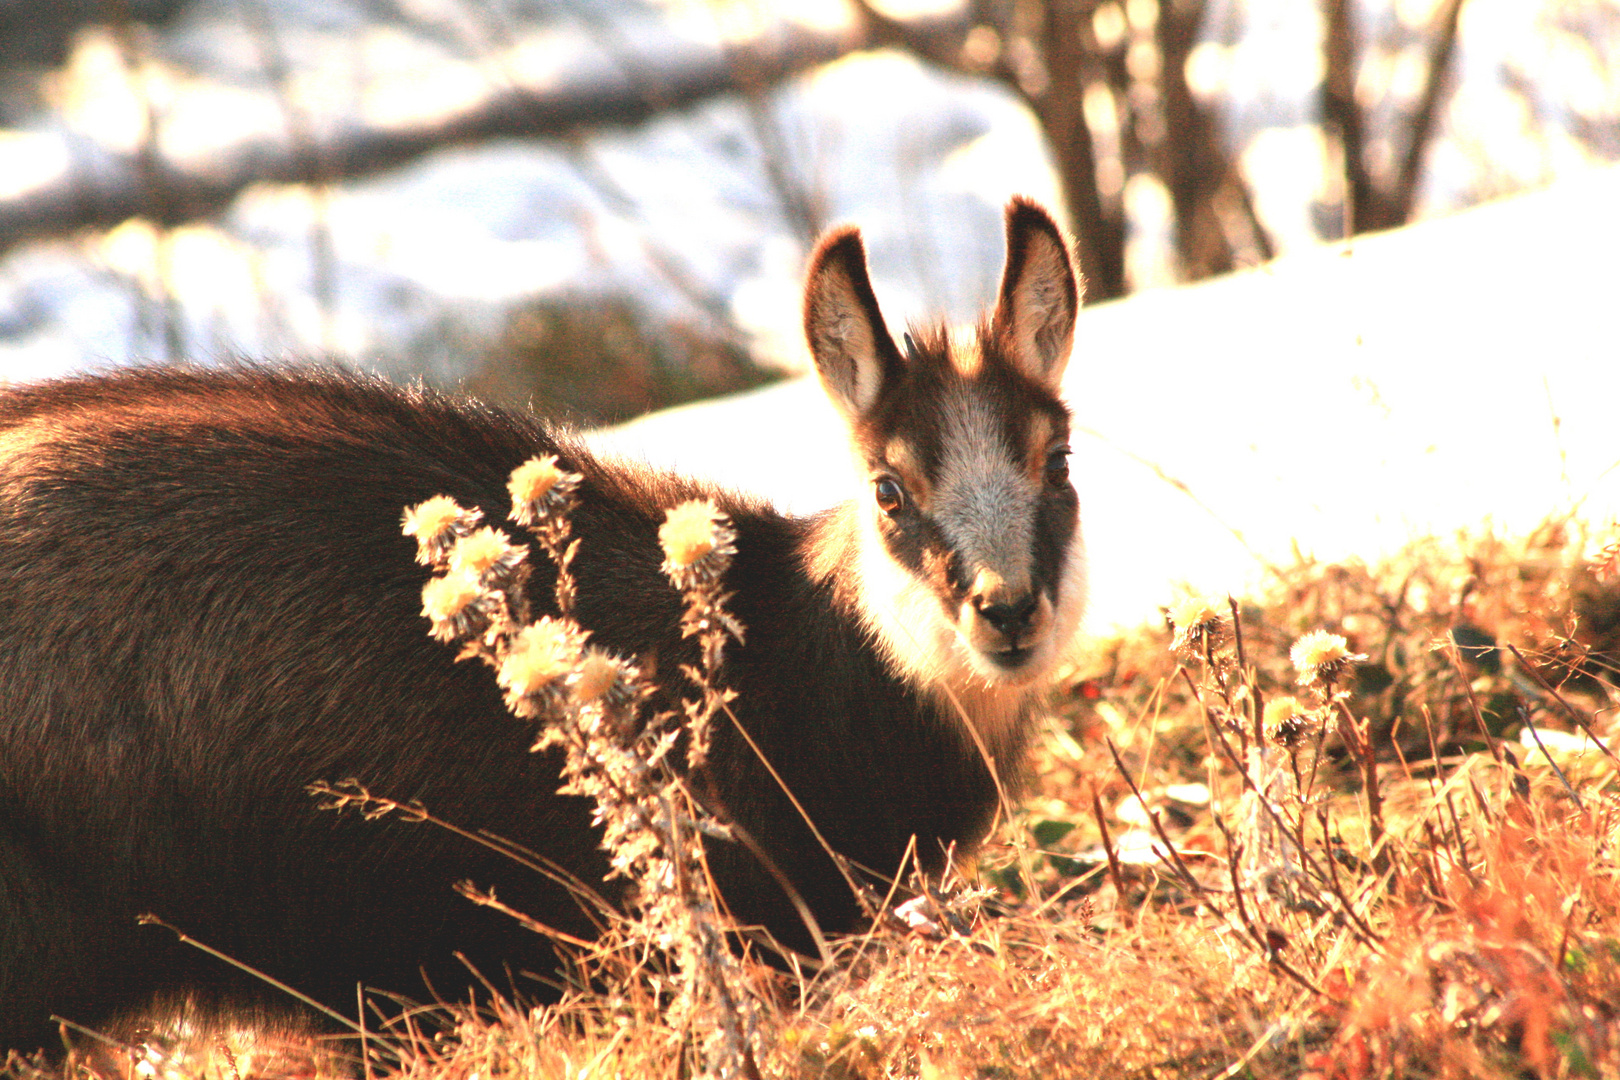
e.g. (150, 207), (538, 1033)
(8, 523), (1620, 1080)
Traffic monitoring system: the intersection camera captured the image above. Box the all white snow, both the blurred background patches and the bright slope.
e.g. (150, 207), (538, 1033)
(0, 0), (1620, 630)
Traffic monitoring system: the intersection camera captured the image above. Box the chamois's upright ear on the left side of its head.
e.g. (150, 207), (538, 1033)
(805, 227), (904, 421)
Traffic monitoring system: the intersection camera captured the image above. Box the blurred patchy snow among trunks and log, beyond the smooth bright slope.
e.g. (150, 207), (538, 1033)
(0, 0), (1620, 388)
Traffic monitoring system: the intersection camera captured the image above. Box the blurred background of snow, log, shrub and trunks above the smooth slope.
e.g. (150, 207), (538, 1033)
(0, 0), (1620, 423)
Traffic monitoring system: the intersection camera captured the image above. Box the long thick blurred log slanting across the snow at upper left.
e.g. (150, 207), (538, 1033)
(0, 26), (865, 253)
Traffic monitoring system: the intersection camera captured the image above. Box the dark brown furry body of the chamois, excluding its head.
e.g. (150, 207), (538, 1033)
(0, 371), (995, 1046)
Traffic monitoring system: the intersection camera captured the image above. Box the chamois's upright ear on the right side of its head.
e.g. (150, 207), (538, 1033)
(991, 196), (1081, 389)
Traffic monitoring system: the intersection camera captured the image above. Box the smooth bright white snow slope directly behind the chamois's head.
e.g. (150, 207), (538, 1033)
(599, 168), (1620, 633)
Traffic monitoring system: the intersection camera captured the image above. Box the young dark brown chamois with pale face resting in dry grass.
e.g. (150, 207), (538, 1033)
(0, 201), (1085, 1048)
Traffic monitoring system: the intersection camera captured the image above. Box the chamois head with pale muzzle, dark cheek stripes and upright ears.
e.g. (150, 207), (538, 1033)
(805, 199), (1085, 705)
